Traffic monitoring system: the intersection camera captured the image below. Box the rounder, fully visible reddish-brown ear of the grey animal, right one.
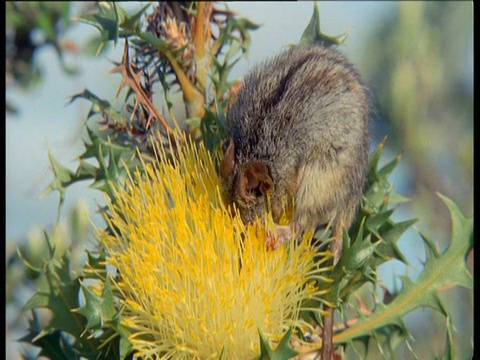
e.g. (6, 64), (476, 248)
(239, 161), (273, 202)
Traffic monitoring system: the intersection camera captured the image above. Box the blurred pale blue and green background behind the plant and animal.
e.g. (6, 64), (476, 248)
(5, 1), (473, 359)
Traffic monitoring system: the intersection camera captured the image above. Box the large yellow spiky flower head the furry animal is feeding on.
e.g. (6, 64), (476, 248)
(97, 136), (330, 359)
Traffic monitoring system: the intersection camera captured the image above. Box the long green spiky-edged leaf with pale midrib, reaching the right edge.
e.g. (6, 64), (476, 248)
(333, 195), (473, 343)
